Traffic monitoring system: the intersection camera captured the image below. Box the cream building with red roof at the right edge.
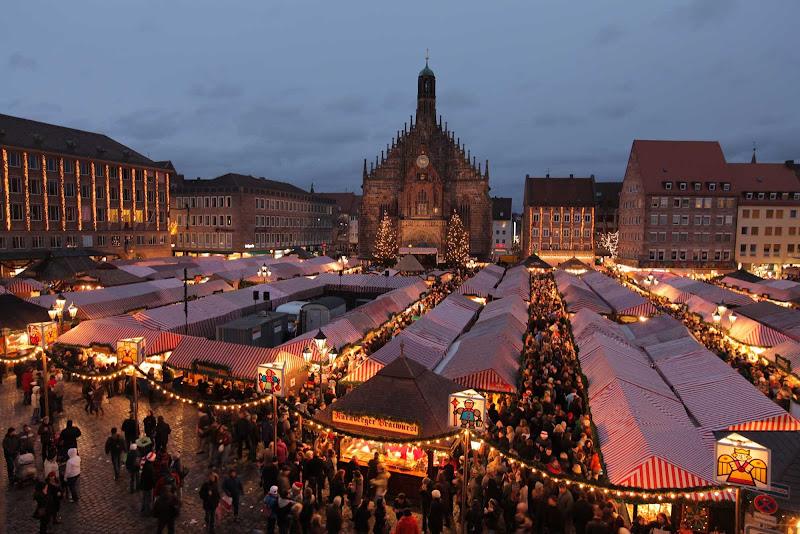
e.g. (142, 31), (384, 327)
(728, 160), (800, 276)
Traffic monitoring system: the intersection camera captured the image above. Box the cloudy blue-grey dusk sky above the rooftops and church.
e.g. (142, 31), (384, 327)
(0, 0), (800, 210)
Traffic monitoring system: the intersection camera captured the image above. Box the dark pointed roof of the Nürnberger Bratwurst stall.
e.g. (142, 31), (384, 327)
(314, 355), (464, 439)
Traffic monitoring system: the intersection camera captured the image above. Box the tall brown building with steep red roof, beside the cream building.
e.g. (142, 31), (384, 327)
(617, 140), (737, 269)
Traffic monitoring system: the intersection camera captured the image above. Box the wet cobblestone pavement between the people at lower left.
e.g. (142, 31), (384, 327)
(0, 374), (421, 534)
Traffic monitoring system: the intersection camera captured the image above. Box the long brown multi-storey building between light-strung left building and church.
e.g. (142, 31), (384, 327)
(172, 173), (335, 254)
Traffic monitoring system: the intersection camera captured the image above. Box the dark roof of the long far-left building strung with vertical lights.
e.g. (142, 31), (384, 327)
(0, 114), (156, 167)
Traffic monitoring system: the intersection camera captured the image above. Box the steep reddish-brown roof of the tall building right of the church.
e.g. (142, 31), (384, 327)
(631, 139), (731, 195)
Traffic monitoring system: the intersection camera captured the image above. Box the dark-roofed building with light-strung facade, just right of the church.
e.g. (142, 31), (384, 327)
(522, 174), (595, 265)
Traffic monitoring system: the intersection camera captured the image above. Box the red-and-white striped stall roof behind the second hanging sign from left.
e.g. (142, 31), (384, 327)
(57, 319), (182, 355)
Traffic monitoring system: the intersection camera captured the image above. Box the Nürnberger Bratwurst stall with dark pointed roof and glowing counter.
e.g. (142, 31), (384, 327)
(314, 353), (478, 495)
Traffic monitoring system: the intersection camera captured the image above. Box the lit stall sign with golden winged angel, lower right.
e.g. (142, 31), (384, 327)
(714, 434), (772, 490)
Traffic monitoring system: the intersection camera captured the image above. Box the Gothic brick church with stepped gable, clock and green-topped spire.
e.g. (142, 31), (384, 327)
(359, 61), (492, 257)
